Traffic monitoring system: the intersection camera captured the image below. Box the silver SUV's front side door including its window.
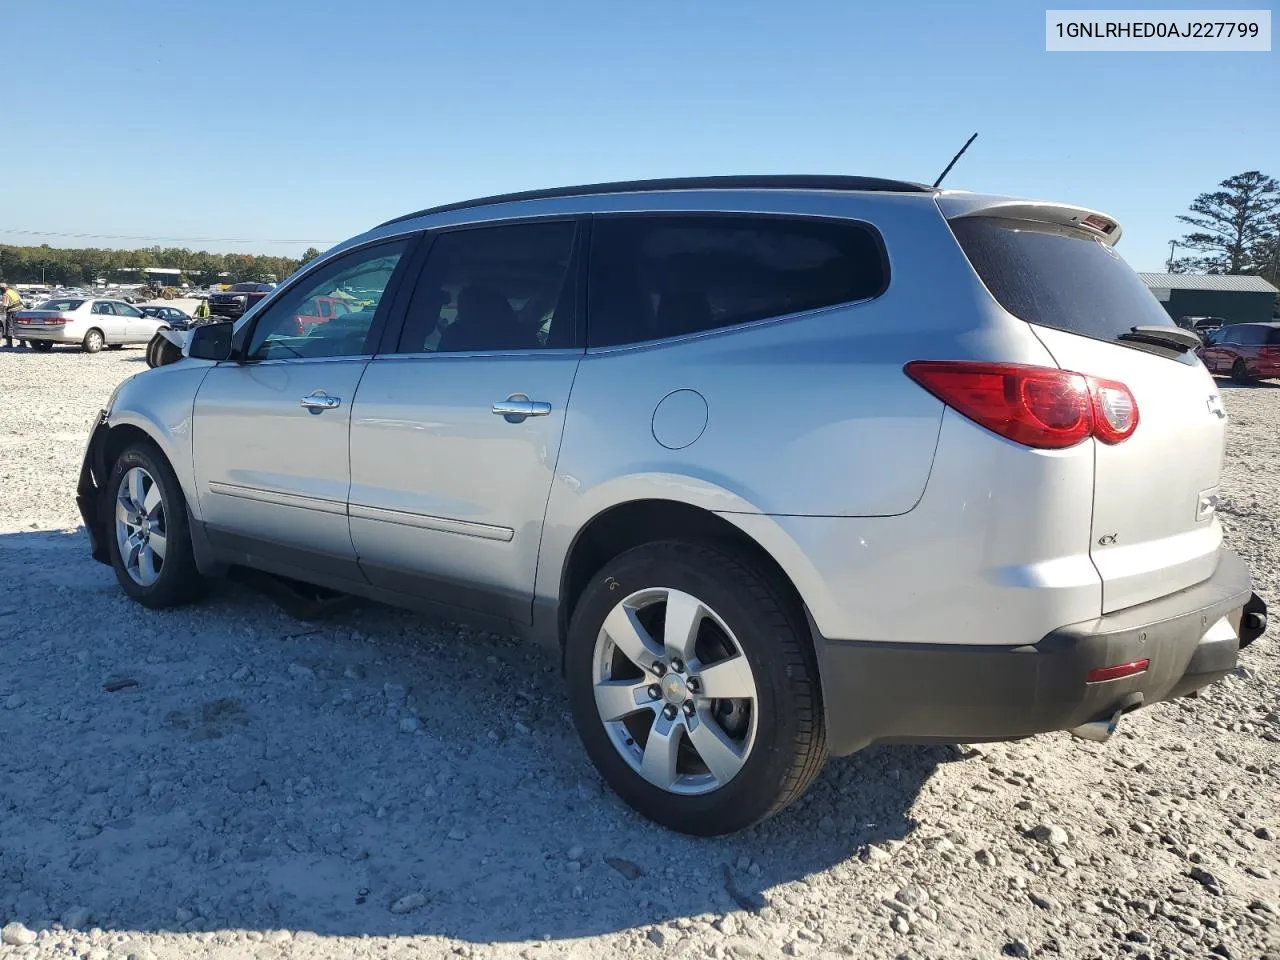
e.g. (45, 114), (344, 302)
(193, 241), (407, 581)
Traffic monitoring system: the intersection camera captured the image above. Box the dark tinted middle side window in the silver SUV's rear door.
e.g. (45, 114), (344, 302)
(399, 221), (577, 353)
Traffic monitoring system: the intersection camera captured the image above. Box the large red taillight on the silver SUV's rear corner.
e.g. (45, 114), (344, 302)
(905, 360), (1138, 449)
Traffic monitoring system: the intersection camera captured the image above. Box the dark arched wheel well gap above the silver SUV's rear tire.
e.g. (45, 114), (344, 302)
(558, 500), (804, 645)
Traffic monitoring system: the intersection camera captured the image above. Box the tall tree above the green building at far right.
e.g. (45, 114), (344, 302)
(1169, 170), (1280, 287)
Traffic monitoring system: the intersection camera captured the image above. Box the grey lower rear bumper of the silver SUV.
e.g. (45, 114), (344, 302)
(818, 550), (1266, 755)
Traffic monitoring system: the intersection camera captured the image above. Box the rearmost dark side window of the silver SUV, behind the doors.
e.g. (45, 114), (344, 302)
(588, 215), (888, 347)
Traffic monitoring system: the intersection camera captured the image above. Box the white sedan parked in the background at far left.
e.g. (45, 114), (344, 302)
(13, 297), (169, 353)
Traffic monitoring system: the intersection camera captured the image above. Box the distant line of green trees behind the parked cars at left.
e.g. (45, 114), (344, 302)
(0, 244), (320, 285)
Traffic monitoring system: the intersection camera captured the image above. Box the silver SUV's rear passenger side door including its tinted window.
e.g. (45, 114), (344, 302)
(348, 221), (582, 623)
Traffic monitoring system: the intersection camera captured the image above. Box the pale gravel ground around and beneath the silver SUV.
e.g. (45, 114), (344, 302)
(0, 349), (1280, 960)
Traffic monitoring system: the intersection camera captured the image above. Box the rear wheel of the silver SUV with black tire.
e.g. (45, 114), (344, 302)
(564, 541), (827, 836)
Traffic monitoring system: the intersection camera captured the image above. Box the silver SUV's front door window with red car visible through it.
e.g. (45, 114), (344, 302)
(246, 241), (408, 360)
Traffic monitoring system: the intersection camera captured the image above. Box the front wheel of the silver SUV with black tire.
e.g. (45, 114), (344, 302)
(104, 443), (204, 609)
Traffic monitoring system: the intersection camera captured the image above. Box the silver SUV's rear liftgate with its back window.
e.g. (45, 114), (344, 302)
(951, 216), (1226, 613)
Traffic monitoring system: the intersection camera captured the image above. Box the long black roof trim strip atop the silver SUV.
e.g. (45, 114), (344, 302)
(379, 174), (933, 227)
